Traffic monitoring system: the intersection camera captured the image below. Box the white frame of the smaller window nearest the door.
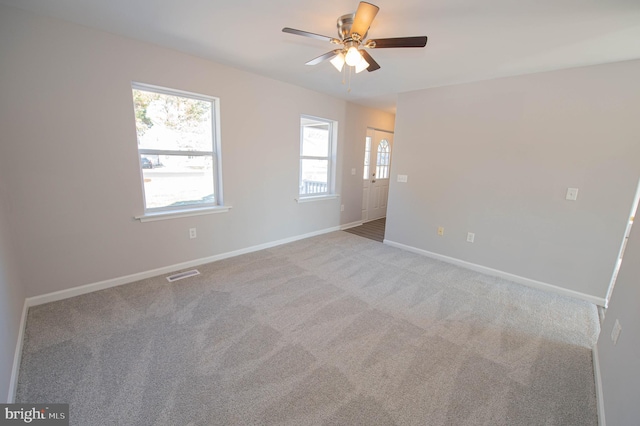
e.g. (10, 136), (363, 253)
(296, 114), (338, 203)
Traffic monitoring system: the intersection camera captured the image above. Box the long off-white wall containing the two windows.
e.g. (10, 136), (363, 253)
(0, 7), (393, 296)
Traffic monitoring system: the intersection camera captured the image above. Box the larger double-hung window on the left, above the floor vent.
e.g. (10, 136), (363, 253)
(132, 83), (222, 214)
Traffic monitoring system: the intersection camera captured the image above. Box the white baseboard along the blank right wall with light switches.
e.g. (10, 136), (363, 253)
(384, 239), (606, 306)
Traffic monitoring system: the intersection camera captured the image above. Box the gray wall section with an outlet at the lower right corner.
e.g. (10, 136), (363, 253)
(598, 220), (640, 426)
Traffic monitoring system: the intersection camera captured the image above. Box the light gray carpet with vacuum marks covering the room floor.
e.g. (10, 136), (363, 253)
(17, 232), (599, 426)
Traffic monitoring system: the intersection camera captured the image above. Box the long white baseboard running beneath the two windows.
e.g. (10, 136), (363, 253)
(25, 226), (340, 308)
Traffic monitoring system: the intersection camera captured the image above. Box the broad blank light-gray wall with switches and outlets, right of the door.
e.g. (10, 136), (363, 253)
(386, 61), (640, 299)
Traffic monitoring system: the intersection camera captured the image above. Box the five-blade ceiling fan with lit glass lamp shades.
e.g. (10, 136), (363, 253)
(282, 1), (427, 73)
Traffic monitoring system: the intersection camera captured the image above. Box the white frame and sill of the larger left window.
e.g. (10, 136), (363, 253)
(131, 82), (231, 222)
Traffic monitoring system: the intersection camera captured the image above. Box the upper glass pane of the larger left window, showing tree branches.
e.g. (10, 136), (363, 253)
(133, 89), (213, 152)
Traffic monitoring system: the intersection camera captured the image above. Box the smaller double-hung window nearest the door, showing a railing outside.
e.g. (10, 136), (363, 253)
(299, 116), (337, 197)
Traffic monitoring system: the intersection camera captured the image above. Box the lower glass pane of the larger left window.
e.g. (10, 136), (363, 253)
(140, 155), (216, 209)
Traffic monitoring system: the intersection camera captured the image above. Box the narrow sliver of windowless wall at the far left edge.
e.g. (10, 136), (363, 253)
(0, 166), (25, 402)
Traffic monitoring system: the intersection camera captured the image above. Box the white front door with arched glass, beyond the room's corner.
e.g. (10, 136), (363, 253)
(362, 129), (393, 222)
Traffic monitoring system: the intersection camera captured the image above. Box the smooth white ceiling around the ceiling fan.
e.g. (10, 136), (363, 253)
(0, 0), (640, 111)
